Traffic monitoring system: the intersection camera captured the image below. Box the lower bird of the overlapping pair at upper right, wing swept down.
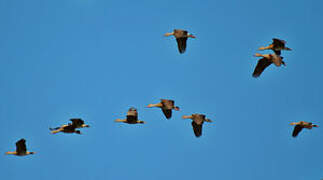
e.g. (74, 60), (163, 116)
(252, 53), (286, 78)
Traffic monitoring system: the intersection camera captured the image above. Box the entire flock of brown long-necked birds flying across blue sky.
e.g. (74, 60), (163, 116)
(6, 29), (318, 156)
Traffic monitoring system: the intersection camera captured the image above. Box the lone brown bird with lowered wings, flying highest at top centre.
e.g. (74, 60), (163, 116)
(165, 29), (196, 54)
